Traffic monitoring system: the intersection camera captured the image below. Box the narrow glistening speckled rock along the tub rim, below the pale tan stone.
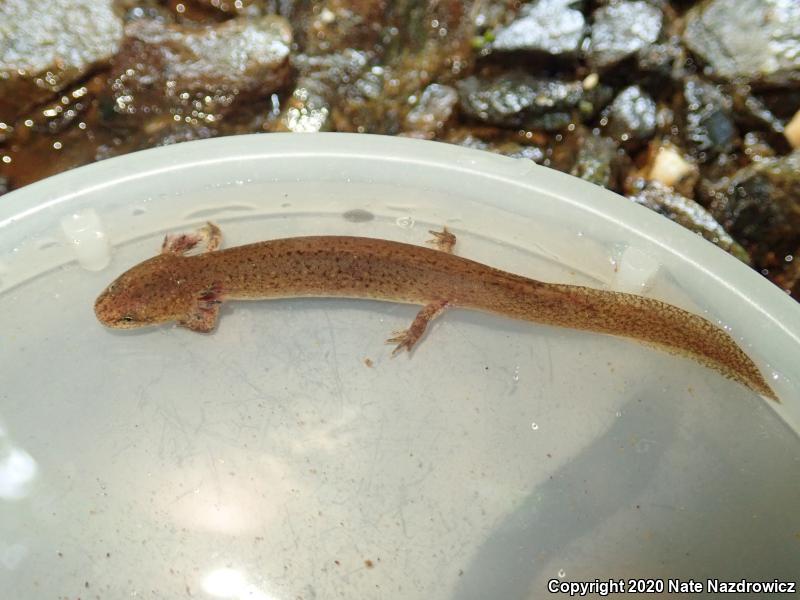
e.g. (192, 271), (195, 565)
(630, 182), (750, 264)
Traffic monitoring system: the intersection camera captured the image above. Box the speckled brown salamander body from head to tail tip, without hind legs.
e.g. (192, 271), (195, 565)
(95, 236), (777, 400)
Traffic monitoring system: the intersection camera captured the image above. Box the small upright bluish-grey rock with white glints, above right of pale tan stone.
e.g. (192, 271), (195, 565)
(683, 77), (738, 161)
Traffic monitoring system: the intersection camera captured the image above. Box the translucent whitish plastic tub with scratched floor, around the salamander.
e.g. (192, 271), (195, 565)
(0, 135), (800, 600)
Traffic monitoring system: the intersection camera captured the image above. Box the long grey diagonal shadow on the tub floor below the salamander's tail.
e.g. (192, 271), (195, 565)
(453, 397), (679, 600)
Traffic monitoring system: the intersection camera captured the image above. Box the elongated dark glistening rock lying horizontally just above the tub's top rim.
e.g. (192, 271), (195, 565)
(458, 72), (611, 131)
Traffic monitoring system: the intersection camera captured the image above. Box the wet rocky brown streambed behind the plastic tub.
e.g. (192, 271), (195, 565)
(0, 0), (800, 298)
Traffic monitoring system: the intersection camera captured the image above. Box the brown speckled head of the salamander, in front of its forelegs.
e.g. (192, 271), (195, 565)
(94, 254), (195, 329)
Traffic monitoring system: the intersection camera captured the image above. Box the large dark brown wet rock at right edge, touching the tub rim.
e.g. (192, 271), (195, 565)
(711, 150), (800, 265)
